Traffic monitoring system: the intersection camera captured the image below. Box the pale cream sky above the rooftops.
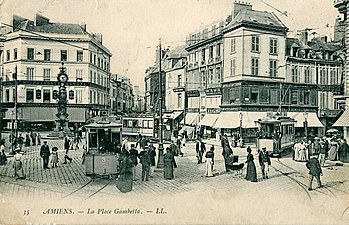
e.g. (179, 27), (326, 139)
(0, 0), (339, 90)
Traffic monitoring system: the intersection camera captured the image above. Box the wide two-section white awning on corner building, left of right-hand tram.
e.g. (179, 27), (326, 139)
(214, 112), (267, 128)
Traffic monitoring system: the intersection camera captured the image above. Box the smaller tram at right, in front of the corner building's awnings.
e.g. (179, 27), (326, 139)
(256, 115), (296, 157)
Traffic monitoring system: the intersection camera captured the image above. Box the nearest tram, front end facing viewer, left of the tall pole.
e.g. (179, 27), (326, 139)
(85, 116), (122, 178)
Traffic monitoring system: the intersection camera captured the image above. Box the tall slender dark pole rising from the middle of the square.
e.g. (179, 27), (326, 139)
(157, 39), (164, 168)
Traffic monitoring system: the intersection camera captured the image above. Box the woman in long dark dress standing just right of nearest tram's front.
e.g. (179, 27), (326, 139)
(116, 152), (134, 193)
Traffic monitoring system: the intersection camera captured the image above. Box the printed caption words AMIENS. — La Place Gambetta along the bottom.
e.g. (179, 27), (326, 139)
(43, 208), (142, 215)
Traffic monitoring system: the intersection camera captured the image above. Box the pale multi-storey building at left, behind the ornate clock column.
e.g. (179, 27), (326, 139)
(1, 15), (112, 128)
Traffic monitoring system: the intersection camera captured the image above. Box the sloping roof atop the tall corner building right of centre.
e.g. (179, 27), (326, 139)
(227, 9), (287, 29)
